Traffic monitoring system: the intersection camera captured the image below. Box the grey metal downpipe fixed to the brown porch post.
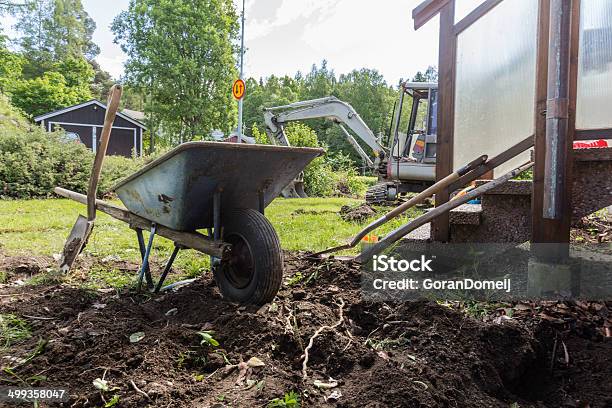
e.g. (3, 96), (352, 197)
(543, 0), (572, 220)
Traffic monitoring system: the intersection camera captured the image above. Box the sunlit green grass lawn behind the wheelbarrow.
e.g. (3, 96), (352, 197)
(0, 198), (419, 286)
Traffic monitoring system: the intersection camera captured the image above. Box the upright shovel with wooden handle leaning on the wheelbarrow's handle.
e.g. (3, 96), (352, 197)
(60, 84), (122, 272)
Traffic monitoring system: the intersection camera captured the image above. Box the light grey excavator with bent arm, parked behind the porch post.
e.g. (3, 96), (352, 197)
(264, 82), (438, 204)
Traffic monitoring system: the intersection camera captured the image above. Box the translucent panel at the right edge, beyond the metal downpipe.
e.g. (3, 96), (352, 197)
(576, 0), (612, 129)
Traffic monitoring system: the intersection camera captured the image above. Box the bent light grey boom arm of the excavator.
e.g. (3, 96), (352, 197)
(264, 96), (387, 167)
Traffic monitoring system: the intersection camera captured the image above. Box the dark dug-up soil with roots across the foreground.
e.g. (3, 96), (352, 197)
(0, 253), (612, 408)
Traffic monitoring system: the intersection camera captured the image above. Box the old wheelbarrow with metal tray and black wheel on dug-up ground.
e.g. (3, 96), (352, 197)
(54, 142), (324, 304)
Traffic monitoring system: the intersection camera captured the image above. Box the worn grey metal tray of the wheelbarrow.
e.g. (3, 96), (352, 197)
(113, 142), (323, 231)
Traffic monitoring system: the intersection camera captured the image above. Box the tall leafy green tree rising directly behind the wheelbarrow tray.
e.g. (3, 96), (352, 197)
(112, 0), (238, 143)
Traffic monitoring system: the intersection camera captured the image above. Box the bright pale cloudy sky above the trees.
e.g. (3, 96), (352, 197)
(3, 0), (444, 85)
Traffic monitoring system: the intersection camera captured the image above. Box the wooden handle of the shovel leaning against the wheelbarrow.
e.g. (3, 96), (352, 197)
(87, 84), (123, 221)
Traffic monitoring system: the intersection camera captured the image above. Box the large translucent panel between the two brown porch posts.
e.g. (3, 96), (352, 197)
(453, 0), (538, 175)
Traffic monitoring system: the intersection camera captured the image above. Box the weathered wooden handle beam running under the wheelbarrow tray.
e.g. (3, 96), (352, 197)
(53, 187), (231, 258)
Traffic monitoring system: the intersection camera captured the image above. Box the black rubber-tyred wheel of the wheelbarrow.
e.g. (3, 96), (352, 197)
(213, 209), (283, 304)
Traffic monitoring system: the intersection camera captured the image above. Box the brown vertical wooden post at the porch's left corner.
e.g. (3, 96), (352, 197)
(431, 1), (457, 242)
